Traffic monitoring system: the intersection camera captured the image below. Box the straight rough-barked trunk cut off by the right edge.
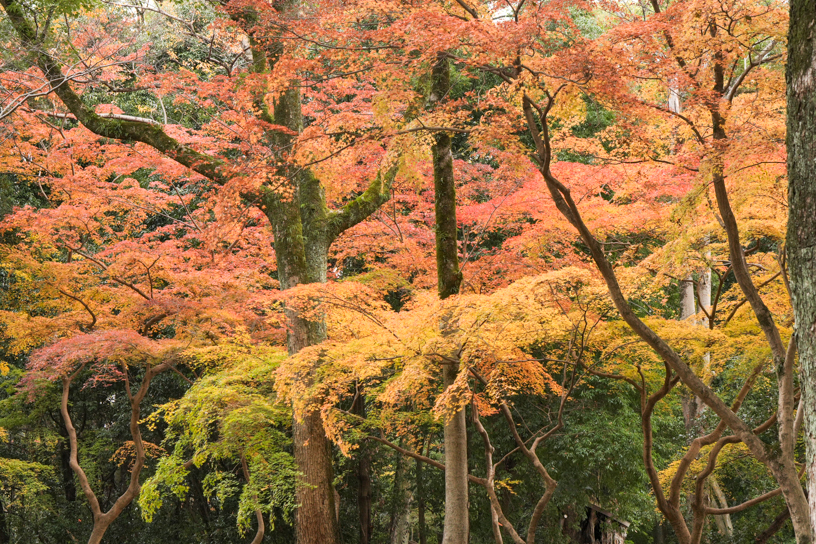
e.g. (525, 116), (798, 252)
(787, 0), (816, 542)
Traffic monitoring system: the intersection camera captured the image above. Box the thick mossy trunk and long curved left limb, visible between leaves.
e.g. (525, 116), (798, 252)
(0, 4), (396, 544)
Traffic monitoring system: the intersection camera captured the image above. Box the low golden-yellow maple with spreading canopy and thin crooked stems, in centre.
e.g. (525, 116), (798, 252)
(274, 269), (605, 542)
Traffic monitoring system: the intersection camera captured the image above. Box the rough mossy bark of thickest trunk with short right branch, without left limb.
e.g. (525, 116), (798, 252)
(234, 23), (396, 544)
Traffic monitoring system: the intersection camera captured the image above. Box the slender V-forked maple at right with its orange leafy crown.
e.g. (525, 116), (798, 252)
(342, 2), (809, 540)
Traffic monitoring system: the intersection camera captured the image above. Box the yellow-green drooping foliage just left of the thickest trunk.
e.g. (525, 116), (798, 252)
(139, 337), (298, 531)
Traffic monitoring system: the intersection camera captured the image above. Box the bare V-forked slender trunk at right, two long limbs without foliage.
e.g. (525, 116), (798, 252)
(506, 3), (812, 542)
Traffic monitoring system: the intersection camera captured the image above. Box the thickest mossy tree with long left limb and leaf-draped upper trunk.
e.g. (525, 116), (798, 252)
(2, 1), (396, 543)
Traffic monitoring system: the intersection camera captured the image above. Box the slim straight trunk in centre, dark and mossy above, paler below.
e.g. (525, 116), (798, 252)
(431, 56), (470, 544)
